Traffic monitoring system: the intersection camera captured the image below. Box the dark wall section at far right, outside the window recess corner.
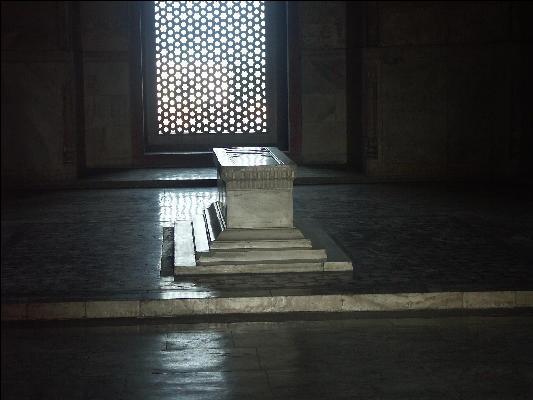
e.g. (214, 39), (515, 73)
(352, 2), (531, 177)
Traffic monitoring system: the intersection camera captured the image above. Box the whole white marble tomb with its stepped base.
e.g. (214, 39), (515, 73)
(174, 147), (353, 277)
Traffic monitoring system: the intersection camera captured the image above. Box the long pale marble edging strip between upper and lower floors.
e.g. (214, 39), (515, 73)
(2, 291), (533, 321)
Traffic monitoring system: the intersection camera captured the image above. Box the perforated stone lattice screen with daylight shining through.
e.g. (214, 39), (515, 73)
(154, 1), (267, 135)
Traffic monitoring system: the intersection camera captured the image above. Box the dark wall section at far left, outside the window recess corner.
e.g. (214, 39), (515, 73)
(1, 1), (76, 183)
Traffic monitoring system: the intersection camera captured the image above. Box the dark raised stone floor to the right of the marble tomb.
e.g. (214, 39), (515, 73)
(295, 183), (533, 292)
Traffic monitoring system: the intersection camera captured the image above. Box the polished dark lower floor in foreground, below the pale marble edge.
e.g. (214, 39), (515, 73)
(2, 314), (533, 400)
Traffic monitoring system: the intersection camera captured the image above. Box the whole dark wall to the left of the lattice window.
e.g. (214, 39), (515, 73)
(2, 1), (133, 184)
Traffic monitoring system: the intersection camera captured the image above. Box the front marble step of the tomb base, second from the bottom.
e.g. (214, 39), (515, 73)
(197, 249), (327, 265)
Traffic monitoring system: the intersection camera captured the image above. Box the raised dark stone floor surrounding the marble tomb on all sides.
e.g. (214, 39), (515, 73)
(1, 183), (533, 302)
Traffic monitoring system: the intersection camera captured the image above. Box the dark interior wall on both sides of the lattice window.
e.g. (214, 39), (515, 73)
(1, 1), (532, 183)
